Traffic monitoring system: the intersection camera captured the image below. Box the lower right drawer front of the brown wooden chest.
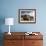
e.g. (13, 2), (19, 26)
(24, 40), (43, 46)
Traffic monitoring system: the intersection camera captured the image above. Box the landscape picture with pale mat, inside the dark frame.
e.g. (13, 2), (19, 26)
(20, 10), (35, 22)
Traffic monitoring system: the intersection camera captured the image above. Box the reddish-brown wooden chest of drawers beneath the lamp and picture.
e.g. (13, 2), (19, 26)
(4, 32), (43, 46)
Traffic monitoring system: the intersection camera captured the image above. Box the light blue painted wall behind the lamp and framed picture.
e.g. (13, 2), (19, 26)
(0, 0), (46, 45)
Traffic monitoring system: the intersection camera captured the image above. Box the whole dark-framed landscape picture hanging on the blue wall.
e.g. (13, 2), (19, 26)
(18, 9), (36, 23)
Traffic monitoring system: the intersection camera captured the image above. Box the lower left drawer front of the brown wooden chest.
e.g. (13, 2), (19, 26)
(4, 40), (24, 46)
